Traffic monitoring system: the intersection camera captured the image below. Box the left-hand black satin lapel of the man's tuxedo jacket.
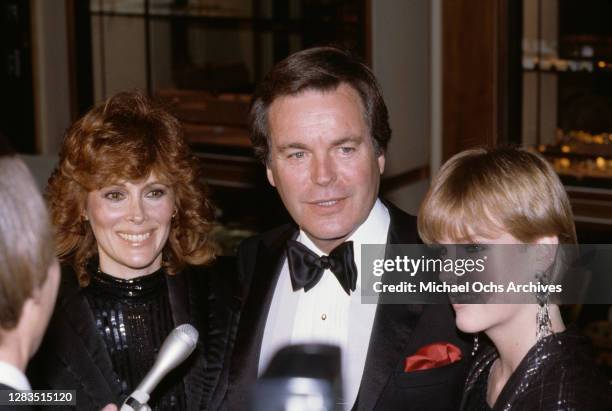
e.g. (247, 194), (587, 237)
(230, 227), (297, 405)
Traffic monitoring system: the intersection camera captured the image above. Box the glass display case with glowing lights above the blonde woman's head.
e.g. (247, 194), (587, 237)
(522, 0), (612, 189)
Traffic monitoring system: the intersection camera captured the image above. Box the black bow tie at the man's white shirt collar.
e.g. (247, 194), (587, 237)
(287, 240), (357, 295)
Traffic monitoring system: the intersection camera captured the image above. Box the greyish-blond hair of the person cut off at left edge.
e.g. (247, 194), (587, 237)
(0, 156), (55, 330)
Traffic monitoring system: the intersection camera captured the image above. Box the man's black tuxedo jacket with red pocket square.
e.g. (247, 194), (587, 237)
(228, 203), (470, 411)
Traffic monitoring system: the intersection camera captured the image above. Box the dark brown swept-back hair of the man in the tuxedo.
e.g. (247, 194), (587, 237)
(249, 47), (391, 163)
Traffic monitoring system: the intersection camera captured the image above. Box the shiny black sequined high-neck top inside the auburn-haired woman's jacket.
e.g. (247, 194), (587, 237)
(83, 269), (185, 410)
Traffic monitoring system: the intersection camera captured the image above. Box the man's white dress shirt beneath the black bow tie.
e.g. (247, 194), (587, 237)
(259, 200), (390, 410)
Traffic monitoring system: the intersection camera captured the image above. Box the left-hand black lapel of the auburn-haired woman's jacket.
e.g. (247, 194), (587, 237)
(55, 273), (120, 404)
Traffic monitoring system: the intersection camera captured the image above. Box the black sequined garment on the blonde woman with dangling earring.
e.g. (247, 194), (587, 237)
(461, 330), (612, 411)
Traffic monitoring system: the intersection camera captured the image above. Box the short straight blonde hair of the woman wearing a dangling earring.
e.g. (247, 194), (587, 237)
(418, 147), (576, 244)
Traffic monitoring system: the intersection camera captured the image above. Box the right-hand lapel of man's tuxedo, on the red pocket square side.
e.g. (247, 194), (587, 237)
(354, 202), (423, 410)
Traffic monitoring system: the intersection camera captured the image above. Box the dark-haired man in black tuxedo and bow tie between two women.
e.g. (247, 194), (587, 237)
(228, 47), (469, 410)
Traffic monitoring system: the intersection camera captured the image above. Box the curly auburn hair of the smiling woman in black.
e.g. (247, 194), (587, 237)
(46, 92), (214, 286)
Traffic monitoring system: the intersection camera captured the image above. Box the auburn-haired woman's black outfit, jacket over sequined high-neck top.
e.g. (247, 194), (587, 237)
(26, 257), (240, 411)
